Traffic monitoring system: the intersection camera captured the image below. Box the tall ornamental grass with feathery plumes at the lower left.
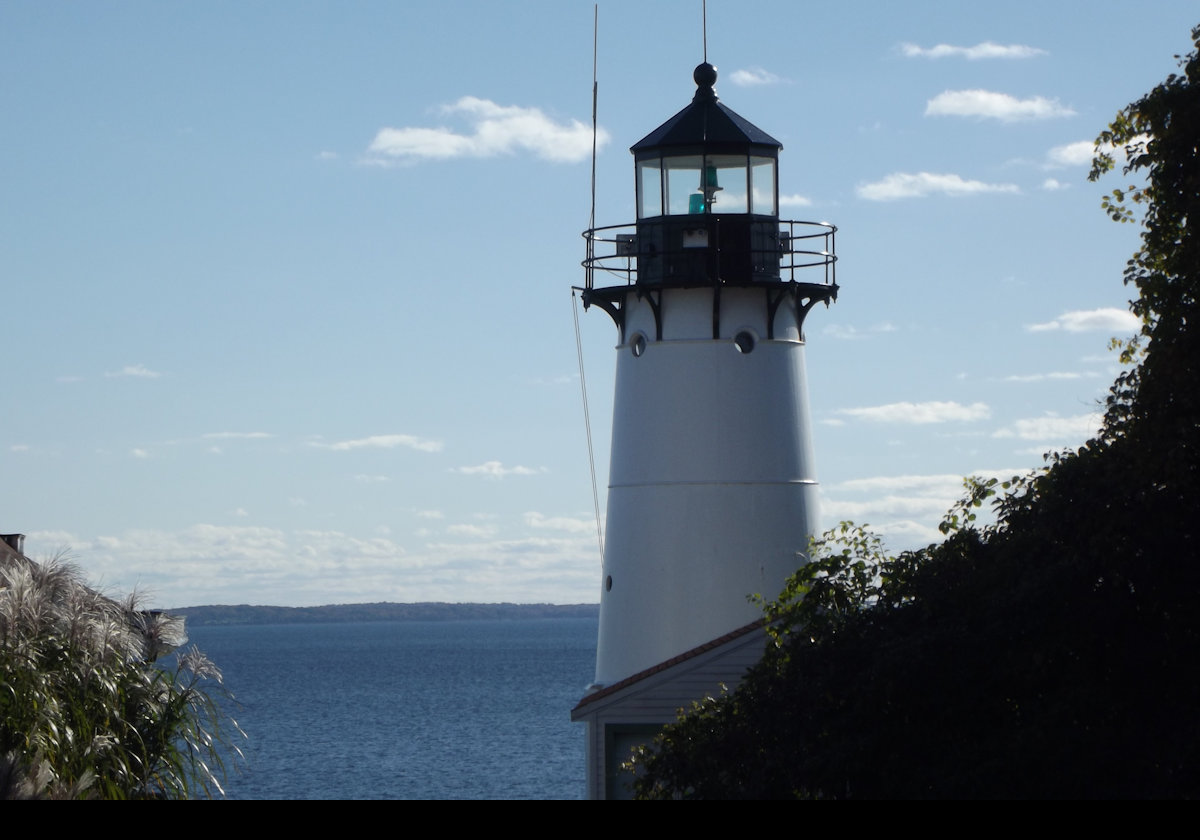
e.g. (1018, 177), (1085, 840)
(0, 554), (240, 799)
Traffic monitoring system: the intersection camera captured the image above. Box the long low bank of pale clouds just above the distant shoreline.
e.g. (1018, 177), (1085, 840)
(25, 523), (609, 608)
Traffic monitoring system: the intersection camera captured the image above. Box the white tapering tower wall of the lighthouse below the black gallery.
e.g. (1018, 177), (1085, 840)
(596, 289), (817, 685)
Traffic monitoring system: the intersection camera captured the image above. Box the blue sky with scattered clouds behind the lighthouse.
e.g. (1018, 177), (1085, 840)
(0, 0), (1200, 607)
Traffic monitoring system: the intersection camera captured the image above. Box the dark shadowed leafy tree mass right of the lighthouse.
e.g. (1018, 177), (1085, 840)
(635, 28), (1200, 798)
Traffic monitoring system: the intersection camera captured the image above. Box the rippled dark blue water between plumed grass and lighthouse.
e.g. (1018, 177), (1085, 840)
(188, 618), (596, 799)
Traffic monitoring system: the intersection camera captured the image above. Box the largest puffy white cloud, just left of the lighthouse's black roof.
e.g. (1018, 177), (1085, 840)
(367, 96), (608, 164)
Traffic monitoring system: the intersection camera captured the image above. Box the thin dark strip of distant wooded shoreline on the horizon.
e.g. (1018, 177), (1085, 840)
(166, 602), (600, 626)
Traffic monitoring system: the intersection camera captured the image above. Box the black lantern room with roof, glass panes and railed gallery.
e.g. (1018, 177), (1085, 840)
(583, 62), (838, 338)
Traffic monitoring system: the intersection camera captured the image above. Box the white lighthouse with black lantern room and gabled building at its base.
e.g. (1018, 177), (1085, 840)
(572, 62), (838, 797)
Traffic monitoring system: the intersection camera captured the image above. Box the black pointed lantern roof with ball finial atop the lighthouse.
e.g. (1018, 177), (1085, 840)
(629, 62), (784, 158)
